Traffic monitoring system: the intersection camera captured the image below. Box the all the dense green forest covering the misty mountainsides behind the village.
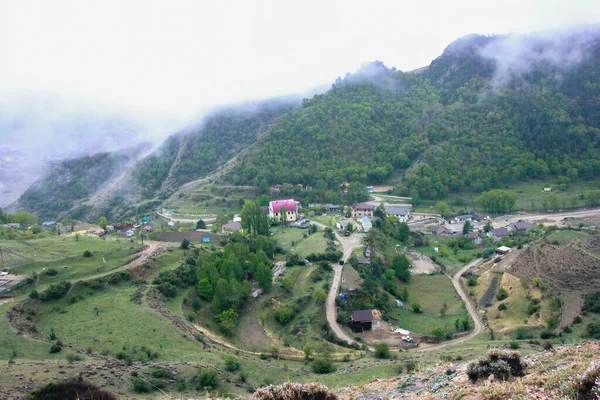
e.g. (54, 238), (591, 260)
(12, 27), (600, 219)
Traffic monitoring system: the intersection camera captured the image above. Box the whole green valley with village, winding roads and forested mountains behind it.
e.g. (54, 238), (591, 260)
(0, 25), (600, 400)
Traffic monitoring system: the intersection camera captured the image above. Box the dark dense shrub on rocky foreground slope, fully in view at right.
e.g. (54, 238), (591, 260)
(467, 349), (526, 382)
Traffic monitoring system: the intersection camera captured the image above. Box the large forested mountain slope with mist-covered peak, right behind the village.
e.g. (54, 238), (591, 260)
(231, 27), (600, 199)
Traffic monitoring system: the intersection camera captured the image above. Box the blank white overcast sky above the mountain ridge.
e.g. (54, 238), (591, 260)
(0, 0), (600, 120)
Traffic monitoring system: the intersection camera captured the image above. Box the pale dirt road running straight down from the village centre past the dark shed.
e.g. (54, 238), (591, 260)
(314, 222), (362, 344)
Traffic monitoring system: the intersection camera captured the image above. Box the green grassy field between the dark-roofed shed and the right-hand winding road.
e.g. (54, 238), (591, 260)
(391, 275), (468, 335)
